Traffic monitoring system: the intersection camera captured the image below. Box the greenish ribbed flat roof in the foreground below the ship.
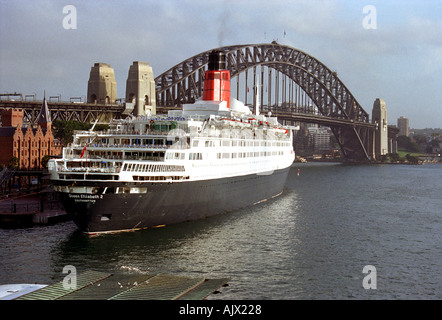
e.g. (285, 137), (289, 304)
(14, 270), (229, 300)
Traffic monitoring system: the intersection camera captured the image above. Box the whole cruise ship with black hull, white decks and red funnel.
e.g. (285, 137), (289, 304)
(48, 51), (295, 234)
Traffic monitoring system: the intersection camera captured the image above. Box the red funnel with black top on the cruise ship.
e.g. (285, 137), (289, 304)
(203, 51), (230, 108)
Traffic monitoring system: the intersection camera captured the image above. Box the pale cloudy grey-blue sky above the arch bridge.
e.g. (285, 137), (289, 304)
(0, 0), (442, 129)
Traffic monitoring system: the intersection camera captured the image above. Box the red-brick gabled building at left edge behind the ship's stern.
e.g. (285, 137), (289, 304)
(0, 99), (62, 170)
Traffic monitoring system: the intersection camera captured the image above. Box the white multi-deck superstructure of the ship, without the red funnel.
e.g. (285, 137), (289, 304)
(49, 99), (295, 188)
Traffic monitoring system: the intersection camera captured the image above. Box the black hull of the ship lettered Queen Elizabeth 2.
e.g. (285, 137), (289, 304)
(58, 168), (289, 233)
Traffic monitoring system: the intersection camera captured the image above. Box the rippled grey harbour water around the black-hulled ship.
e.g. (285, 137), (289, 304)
(0, 163), (442, 300)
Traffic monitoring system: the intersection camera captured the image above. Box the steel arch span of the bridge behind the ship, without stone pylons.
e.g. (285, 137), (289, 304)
(155, 42), (375, 161)
